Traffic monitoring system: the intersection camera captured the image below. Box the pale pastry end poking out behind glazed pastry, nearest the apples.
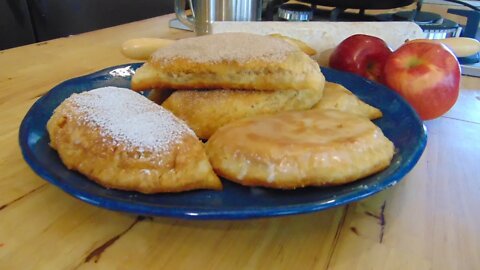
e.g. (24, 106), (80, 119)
(313, 82), (382, 120)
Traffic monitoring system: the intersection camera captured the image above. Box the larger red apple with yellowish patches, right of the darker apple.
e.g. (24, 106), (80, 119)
(384, 42), (461, 120)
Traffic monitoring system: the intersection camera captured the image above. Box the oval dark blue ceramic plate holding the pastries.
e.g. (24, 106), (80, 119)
(20, 64), (427, 219)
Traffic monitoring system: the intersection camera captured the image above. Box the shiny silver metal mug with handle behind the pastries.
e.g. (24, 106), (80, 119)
(175, 0), (262, 35)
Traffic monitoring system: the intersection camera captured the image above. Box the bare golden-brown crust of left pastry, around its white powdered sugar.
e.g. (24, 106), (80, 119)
(47, 87), (222, 193)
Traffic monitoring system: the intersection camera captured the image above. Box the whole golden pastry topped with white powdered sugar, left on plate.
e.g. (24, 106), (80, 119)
(47, 87), (222, 193)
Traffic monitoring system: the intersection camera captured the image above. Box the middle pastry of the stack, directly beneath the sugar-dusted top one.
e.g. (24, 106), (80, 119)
(160, 84), (322, 139)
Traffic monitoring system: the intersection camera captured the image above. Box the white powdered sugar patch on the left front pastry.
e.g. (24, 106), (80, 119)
(61, 87), (195, 152)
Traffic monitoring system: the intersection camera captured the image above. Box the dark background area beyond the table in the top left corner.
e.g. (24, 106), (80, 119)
(0, 0), (173, 50)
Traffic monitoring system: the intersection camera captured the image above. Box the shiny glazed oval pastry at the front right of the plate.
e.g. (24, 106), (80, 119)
(206, 110), (394, 189)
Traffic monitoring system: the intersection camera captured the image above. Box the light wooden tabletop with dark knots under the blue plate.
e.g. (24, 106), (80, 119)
(0, 13), (480, 270)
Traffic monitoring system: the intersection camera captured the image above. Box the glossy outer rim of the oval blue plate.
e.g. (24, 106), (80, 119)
(18, 63), (428, 220)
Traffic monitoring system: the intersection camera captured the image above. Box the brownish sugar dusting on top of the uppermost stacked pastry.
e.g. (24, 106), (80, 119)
(153, 33), (298, 63)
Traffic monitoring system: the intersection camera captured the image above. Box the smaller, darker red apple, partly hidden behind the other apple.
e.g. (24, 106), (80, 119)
(329, 34), (392, 82)
